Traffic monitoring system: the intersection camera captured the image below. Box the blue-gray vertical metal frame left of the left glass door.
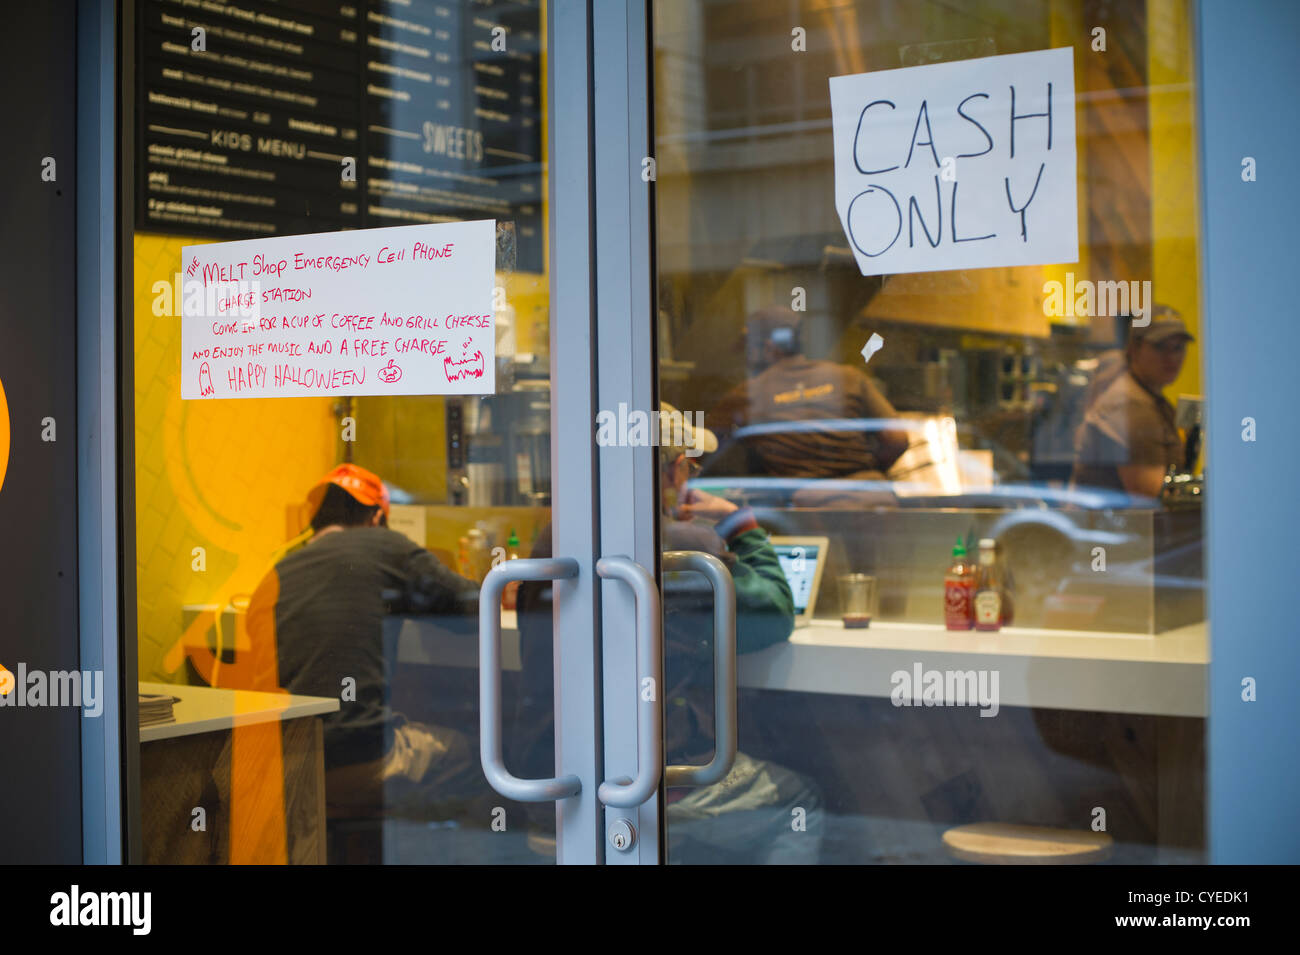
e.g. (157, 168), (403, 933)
(75, 0), (130, 864)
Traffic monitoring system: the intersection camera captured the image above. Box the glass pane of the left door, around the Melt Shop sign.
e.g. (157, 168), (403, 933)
(134, 0), (555, 863)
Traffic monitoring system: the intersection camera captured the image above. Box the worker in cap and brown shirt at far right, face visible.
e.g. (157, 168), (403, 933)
(1071, 307), (1195, 499)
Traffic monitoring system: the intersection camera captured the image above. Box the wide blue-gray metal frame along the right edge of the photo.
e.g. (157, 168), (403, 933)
(1196, 0), (1300, 864)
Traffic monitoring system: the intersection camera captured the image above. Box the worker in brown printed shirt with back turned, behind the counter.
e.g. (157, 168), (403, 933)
(709, 305), (907, 478)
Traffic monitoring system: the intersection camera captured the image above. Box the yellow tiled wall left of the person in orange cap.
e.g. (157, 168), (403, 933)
(134, 235), (339, 682)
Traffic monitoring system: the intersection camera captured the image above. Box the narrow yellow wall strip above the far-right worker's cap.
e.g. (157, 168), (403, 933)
(1147, 0), (1205, 399)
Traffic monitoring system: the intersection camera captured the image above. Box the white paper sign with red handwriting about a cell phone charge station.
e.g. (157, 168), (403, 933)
(181, 220), (497, 399)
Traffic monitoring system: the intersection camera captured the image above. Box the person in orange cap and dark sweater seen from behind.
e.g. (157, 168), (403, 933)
(248, 464), (478, 831)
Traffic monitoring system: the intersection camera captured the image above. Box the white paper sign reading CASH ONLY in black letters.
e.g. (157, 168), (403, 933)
(831, 47), (1079, 275)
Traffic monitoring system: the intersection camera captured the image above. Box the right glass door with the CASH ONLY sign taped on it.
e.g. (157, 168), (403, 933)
(624, 0), (1208, 864)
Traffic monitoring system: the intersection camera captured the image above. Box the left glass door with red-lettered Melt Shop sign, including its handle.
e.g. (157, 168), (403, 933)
(124, 0), (602, 864)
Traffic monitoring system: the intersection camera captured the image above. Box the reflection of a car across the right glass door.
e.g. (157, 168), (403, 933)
(689, 417), (1199, 628)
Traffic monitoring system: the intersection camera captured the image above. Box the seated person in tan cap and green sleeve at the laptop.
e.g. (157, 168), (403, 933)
(512, 405), (823, 863)
